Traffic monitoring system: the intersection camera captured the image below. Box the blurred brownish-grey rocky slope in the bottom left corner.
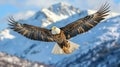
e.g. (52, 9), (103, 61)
(0, 52), (50, 67)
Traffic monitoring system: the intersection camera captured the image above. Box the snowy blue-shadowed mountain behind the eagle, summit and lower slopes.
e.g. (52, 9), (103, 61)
(0, 3), (120, 67)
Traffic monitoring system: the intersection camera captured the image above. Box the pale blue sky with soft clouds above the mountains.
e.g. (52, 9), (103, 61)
(0, 0), (120, 19)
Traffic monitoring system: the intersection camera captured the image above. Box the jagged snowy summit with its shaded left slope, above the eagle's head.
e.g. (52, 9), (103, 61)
(22, 2), (80, 27)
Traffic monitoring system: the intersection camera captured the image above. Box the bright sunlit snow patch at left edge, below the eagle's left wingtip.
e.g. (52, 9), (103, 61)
(0, 29), (15, 40)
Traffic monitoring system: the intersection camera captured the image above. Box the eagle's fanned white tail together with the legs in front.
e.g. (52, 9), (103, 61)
(52, 41), (79, 54)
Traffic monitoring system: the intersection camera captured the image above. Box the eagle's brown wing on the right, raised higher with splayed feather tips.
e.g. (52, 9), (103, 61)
(61, 3), (110, 39)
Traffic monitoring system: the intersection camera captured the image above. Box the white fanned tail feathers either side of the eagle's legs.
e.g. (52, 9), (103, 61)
(52, 41), (80, 54)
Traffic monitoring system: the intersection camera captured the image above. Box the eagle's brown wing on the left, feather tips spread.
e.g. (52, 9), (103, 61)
(8, 18), (54, 42)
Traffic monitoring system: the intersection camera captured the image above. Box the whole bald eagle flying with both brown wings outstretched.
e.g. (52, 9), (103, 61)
(8, 3), (110, 54)
